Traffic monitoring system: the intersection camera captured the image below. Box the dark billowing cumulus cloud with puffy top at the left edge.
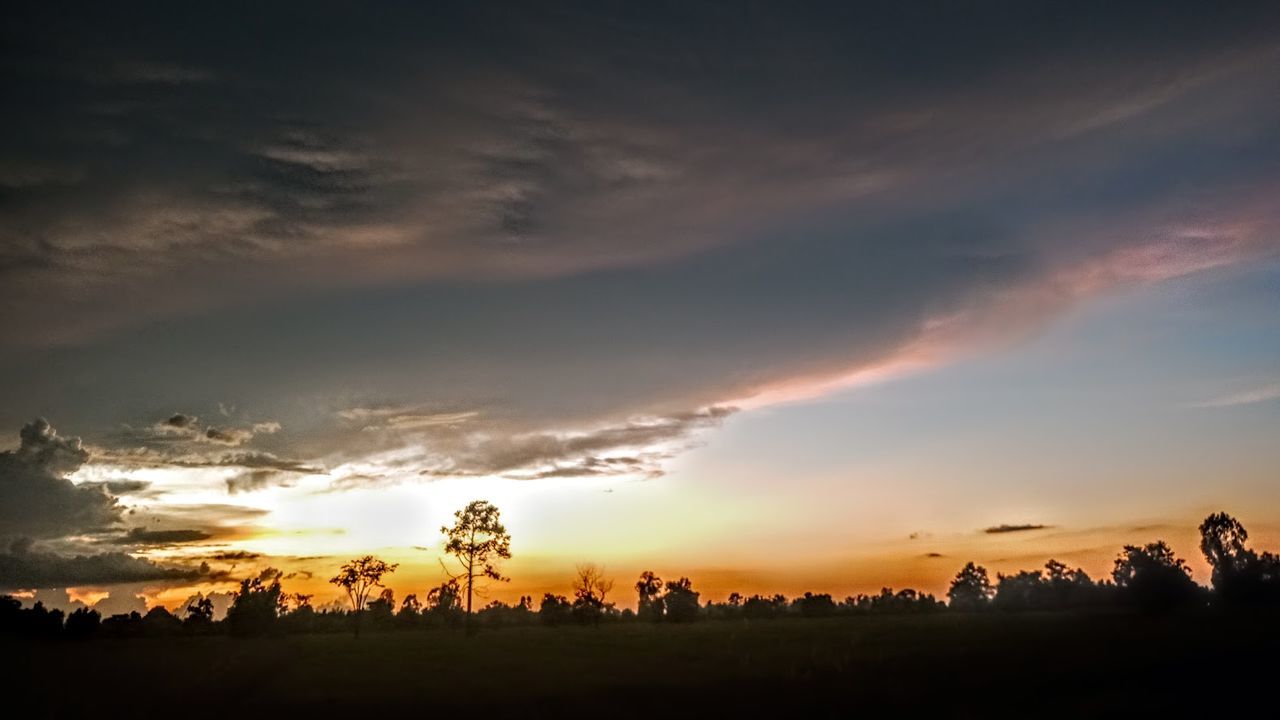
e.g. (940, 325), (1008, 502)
(0, 419), (122, 539)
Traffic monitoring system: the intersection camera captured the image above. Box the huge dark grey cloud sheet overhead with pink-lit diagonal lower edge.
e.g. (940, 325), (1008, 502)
(0, 4), (1280, 476)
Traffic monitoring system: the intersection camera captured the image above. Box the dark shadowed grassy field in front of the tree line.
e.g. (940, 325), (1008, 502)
(3, 614), (1280, 720)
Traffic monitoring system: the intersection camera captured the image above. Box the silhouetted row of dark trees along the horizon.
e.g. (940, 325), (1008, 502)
(0, 501), (1280, 639)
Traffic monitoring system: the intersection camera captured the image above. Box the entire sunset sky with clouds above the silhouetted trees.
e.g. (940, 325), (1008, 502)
(0, 3), (1280, 612)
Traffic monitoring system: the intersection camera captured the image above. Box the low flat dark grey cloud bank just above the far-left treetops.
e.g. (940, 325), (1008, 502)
(0, 546), (210, 591)
